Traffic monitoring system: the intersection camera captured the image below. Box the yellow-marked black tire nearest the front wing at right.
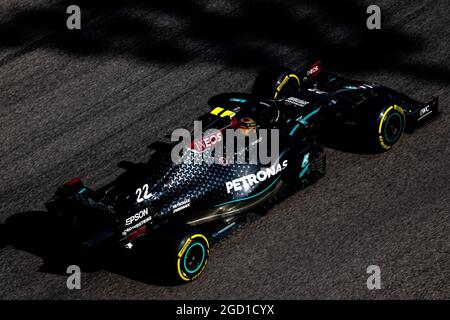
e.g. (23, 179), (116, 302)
(362, 104), (406, 152)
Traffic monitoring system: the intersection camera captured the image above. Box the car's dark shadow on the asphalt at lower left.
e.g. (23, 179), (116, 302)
(0, 211), (183, 286)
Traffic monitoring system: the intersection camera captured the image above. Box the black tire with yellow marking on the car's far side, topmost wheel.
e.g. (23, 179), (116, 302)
(252, 66), (300, 99)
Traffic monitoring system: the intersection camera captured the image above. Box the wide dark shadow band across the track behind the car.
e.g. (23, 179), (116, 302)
(0, 0), (450, 83)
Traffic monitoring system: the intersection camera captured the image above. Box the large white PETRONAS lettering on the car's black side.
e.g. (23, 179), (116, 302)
(225, 160), (288, 193)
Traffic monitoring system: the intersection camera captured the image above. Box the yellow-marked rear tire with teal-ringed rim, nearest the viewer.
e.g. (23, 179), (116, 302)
(154, 223), (210, 283)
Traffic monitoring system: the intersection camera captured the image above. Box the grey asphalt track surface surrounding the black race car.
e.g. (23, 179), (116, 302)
(0, 0), (450, 299)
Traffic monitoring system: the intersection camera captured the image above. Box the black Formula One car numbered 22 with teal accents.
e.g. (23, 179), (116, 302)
(46, 62), (439, 282)
